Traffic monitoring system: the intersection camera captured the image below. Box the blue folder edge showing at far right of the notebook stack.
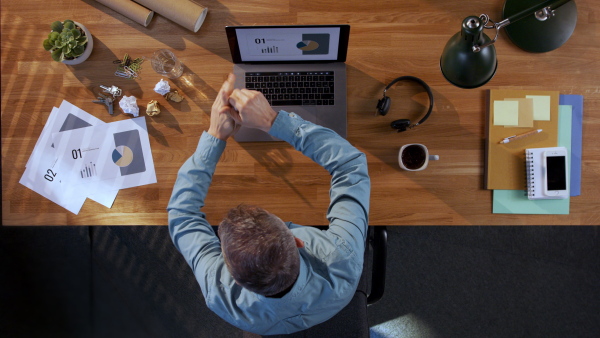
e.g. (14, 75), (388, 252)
(558, 95), (583, 196)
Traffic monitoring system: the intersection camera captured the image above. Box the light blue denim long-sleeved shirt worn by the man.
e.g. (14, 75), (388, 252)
(167, 111), (371, 335)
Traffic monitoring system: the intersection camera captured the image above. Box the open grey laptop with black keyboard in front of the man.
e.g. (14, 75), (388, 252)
(225, 25), (350, 142)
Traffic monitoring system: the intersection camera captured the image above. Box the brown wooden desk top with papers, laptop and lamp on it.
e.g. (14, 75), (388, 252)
(2, 0), (600, 225)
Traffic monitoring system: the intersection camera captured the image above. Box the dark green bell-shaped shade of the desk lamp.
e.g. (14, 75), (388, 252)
(440, 16), (498, 88)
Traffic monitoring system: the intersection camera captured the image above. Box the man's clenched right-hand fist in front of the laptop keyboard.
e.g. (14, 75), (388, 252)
(229, 89), (277, 132)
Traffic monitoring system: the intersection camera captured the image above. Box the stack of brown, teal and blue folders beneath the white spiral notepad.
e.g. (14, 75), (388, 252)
(484, 89), (583, 214)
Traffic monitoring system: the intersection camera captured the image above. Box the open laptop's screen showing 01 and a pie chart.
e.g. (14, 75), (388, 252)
(225, 25), (350, 63)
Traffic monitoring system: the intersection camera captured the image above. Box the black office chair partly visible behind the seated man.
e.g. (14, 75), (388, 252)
(244, 226), (387, 338)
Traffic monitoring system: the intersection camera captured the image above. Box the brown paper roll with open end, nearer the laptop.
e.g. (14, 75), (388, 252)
(134, 0), (208, 33)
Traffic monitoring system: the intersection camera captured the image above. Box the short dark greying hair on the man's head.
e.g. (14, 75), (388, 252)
(219, 204), (300, 296)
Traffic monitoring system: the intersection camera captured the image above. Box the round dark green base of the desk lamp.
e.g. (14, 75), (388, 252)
(502, 0), (577, 53)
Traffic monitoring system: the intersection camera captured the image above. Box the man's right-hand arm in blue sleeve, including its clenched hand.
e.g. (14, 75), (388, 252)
(229, 82), (371, 250)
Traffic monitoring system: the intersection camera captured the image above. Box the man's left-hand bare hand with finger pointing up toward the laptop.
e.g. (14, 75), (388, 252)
(208, 74), (240, 141)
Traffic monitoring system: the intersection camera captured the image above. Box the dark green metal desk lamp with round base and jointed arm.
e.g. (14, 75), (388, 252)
(440, 0), (577, 88)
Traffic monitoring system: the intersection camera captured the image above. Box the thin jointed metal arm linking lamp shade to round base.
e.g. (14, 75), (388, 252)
(473, 0), (571, 53)
